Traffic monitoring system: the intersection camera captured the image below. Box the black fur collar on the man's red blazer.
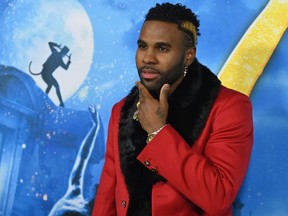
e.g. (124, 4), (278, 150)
(119, 60), (221, 215)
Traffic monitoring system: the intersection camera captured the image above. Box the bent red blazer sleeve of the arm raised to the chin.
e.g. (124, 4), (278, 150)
(138, 90), (253, 215)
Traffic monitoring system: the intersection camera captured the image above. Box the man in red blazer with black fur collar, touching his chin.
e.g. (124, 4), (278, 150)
(93, 3), (253, 216)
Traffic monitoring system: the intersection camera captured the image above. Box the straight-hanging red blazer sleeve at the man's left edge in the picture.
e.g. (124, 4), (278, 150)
(92, 106), (118, 216)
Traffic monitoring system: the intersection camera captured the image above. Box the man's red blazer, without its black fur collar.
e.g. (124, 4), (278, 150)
(92, 87), (253, 216)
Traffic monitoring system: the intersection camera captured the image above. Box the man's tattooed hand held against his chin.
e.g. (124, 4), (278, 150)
(136, 82), (170, 133)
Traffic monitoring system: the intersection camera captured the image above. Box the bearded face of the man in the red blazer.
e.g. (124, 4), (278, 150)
(136, 21), (195, 92)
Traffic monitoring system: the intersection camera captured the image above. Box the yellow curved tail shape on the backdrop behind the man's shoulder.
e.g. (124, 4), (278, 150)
(218, 0), (288, 96)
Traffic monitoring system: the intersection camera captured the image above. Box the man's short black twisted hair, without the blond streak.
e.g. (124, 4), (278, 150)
(145, 2), (200, 46)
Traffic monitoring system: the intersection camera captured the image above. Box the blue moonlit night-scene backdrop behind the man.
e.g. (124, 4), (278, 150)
(0, 0), (288, 216)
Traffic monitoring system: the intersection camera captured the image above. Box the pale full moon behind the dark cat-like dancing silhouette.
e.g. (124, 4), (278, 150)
(0, 0), (94, 105)
